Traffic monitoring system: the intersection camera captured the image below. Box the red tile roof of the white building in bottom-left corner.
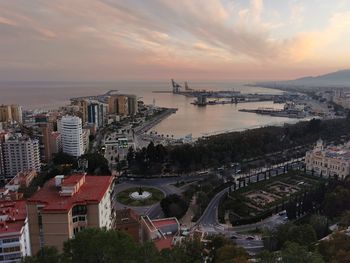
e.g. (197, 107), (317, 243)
(0, 200), (27, 236)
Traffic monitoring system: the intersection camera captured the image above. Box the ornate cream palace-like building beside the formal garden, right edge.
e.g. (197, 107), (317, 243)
(305, 140), (350, 179)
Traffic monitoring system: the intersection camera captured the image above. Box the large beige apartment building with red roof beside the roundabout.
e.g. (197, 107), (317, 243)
(27, 174), (114, 254)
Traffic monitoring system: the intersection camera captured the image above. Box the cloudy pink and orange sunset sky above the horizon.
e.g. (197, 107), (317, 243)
(0, 0), (350, 81)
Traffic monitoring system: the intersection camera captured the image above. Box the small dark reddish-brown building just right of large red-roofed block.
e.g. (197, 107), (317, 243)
(113, 208), (141, 242)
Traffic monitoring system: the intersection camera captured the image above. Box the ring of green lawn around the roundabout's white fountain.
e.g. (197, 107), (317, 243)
(117, 187), (164, 206)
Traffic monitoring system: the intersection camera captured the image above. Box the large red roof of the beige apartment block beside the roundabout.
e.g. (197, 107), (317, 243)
(28, 175), (113, 212)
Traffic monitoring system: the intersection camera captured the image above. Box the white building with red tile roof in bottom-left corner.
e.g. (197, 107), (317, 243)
(0, 200), (32, 263)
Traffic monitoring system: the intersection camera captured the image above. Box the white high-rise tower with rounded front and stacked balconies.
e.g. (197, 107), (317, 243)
(57, 115), (84, 157)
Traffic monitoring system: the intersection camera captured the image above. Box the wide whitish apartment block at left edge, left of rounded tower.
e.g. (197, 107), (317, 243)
(2, 134), (41, 178)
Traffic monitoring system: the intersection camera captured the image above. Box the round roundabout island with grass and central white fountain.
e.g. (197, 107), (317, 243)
(116, 187), (165, 206)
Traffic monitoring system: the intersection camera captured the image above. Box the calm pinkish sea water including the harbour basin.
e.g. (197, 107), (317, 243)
(0, 81), (299, 138)
